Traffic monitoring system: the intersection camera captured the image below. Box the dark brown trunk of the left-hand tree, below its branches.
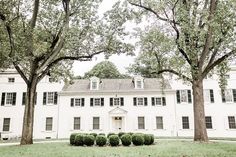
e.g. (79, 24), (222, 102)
(20, 78), (37, 145)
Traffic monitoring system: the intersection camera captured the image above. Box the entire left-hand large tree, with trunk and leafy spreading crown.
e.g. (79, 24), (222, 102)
(0, 0), (132, 145)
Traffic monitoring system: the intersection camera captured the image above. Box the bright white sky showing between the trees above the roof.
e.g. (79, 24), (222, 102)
(72, 0), (135, 76)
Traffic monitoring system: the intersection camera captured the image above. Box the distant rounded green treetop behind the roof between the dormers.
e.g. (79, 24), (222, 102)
(84, 61), (128, 79)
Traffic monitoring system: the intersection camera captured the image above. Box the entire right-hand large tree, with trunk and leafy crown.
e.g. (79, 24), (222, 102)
(122, 0), (236, 141)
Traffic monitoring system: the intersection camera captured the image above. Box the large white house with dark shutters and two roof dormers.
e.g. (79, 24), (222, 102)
(0, 67), (236, 139)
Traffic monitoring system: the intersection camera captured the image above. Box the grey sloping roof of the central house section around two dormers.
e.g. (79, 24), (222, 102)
(62, 78), (171, 92)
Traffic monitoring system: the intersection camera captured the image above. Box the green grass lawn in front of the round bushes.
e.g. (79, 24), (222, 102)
(0, 140), (236, 157)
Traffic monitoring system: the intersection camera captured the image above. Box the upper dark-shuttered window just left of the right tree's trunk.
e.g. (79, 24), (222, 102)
(176, 90), (192, 103)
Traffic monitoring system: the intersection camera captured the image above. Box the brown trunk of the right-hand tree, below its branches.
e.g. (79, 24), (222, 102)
(192, 79), (208, 142)
